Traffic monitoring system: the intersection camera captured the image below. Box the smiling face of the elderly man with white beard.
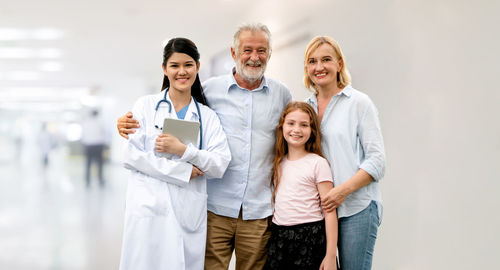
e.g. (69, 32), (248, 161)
(231, 31), (270, 82)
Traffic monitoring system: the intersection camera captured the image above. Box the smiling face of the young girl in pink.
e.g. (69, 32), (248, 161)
(283, 109), (311, 152)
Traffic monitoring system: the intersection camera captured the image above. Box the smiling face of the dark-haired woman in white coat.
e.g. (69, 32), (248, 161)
(162, 52), (200, 92)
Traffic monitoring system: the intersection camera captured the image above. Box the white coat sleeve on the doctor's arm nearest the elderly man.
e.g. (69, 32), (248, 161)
(180, 108), (231, 178)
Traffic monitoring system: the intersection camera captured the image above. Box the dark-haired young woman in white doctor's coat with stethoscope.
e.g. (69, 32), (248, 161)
(120, 38), (231, 270)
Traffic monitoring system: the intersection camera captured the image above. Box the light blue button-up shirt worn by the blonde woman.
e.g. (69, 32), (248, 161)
(306, 85), (385, 220)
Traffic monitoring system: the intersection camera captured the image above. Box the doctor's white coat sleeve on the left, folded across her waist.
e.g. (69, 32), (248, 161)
(123, 98), (193, 187)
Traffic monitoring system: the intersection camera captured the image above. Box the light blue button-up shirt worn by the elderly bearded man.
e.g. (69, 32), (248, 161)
(203, 69), (292, 220)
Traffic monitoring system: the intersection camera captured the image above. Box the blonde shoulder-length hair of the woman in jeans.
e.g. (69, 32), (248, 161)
(304, 36), (351, 94)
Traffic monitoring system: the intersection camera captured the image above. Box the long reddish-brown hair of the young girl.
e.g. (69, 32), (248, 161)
(271, 101), (323, 203)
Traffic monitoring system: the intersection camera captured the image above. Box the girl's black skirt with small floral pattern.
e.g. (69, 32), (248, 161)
(264, 220), (326, 270)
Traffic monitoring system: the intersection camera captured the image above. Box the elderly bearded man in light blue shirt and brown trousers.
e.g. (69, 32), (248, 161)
(117, 24), (292, 270)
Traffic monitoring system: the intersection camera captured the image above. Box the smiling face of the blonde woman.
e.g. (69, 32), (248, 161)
(306, 44), (342, 91)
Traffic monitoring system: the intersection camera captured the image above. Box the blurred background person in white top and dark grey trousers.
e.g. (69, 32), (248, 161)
(82, 109), (107, 187)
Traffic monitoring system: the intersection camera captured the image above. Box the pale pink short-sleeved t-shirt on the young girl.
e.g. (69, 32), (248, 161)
(273, 153), (333, 226)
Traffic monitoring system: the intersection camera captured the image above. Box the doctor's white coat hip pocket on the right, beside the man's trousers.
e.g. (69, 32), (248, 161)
(169, 185), (207, 232)
